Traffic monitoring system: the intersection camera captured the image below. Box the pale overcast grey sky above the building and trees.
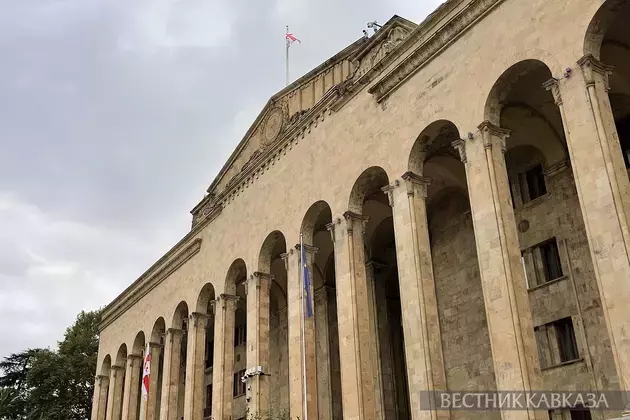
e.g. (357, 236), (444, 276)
(0, 0), (440, 358)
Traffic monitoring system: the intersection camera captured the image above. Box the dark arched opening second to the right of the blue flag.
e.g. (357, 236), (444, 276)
(349, 167), (411, 420)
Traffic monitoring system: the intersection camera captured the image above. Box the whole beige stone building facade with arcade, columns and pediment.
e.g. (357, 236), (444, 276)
(93, 0), (630, 420)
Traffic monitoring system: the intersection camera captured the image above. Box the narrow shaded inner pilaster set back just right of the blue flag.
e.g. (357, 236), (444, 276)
(313, 286), (333, 420)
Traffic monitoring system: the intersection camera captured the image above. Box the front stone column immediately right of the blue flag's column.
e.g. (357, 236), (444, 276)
(328, 212), (376, 420)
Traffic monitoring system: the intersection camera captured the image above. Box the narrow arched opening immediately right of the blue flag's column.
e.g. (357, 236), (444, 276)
(301, 201), (343, 419)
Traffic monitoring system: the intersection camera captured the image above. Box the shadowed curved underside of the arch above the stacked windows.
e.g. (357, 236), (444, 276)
(484, 59), (555, 126)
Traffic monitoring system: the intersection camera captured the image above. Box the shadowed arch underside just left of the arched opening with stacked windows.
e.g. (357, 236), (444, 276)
(407, 120), (460, 175)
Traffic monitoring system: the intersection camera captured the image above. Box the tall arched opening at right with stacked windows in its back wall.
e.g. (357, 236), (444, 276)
(488, 60), (604, 404)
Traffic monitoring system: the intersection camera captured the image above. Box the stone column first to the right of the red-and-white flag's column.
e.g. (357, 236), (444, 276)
(160, 328), (184, 420)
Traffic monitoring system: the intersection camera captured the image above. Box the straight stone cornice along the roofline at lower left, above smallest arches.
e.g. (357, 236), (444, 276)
(99, 238), (201, 331)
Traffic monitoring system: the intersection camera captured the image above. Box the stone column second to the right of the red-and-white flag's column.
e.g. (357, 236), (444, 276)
(184, 312), (209, 420)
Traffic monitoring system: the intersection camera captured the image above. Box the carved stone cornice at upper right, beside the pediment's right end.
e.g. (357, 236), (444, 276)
(368, 0), (503, 102)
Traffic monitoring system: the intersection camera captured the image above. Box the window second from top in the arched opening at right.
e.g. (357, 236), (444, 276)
(522, 238), (563, 288)
